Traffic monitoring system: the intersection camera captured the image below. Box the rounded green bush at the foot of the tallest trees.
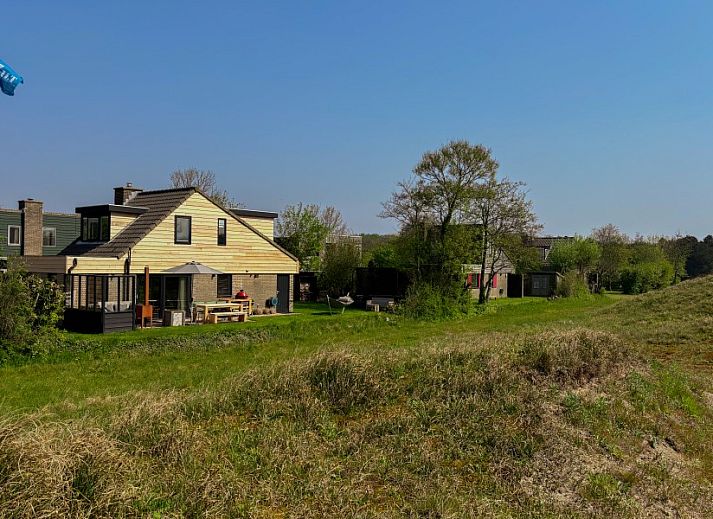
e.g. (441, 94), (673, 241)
(399, 282), (473, 321)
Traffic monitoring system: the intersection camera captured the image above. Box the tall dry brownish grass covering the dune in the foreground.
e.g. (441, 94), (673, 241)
(0, 329), (710, 517)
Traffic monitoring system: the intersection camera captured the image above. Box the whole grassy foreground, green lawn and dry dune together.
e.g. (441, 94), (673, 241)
(0, 286), (713, 517)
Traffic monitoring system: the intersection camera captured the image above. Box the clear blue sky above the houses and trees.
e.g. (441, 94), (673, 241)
(0, 0), (713, 237)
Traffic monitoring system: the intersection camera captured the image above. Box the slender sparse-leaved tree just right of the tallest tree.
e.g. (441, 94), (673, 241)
(467, 177), (539, 304)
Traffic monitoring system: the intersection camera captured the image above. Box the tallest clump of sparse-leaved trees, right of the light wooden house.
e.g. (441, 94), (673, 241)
(382, 141), (537, 308)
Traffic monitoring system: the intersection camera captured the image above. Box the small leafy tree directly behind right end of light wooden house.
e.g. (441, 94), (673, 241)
(275, 203), (329, 270)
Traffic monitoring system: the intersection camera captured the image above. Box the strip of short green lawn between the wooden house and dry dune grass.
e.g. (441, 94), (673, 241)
(0, 296), (617, 417)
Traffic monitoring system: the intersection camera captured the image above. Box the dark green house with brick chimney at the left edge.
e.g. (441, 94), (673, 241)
(0, 198), (80, 269)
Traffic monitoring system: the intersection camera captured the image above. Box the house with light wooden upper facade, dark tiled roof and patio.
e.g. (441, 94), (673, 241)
(25, 184), (299, 332)
